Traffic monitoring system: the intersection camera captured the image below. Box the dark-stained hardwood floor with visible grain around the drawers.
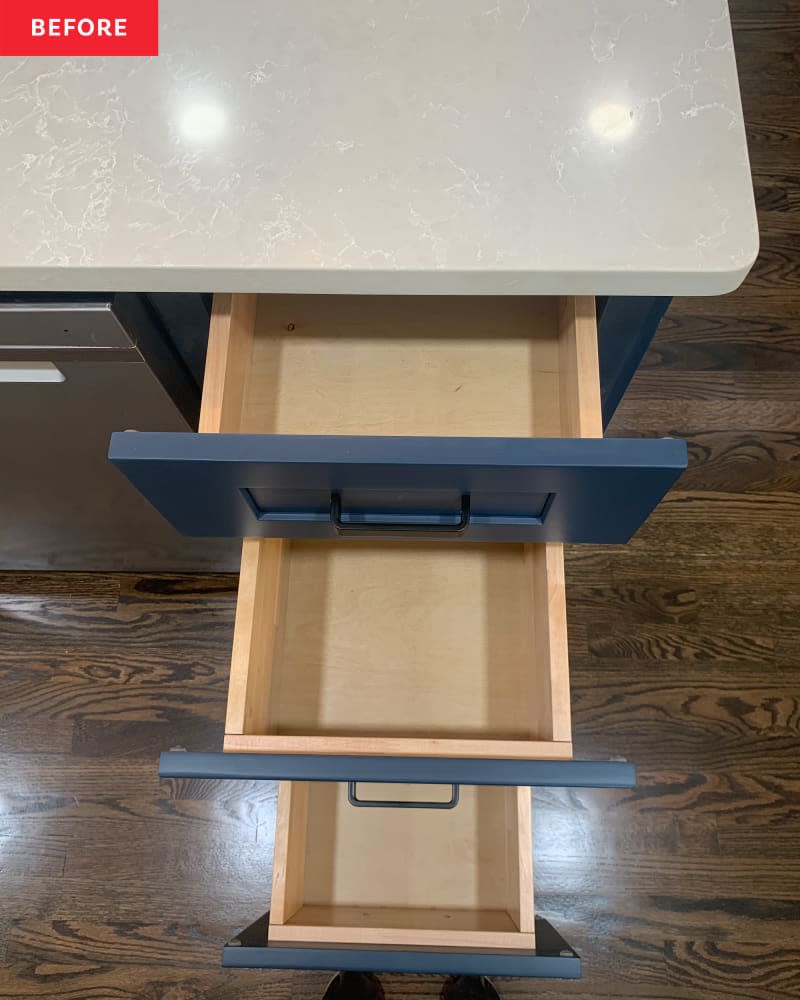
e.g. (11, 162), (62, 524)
(0, 0), (800, 1000)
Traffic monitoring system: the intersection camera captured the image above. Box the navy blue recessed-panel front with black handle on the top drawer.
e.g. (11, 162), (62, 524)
(109, 432), (687, 543)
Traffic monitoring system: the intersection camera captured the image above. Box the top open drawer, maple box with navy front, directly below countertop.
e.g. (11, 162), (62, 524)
(109, 295), (686, 543)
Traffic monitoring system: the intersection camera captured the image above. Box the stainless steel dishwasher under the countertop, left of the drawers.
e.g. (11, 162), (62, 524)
(0, 294), (241, 572)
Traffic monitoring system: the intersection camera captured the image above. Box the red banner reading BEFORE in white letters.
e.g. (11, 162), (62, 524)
(0, 0), (158, 56)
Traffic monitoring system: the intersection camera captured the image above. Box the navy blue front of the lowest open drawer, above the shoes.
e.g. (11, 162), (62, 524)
(222, 913), (581, 979)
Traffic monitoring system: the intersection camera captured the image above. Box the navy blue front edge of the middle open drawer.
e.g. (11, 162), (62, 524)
(158, 750), (636, 788)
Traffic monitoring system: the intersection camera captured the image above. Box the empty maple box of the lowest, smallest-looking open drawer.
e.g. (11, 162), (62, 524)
(269, 781), (534, 951)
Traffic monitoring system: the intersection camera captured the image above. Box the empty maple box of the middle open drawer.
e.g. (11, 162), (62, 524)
(224, 539), (572, 760)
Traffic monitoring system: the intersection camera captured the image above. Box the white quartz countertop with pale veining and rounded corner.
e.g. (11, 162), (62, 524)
(0, 0), (758, 295)
